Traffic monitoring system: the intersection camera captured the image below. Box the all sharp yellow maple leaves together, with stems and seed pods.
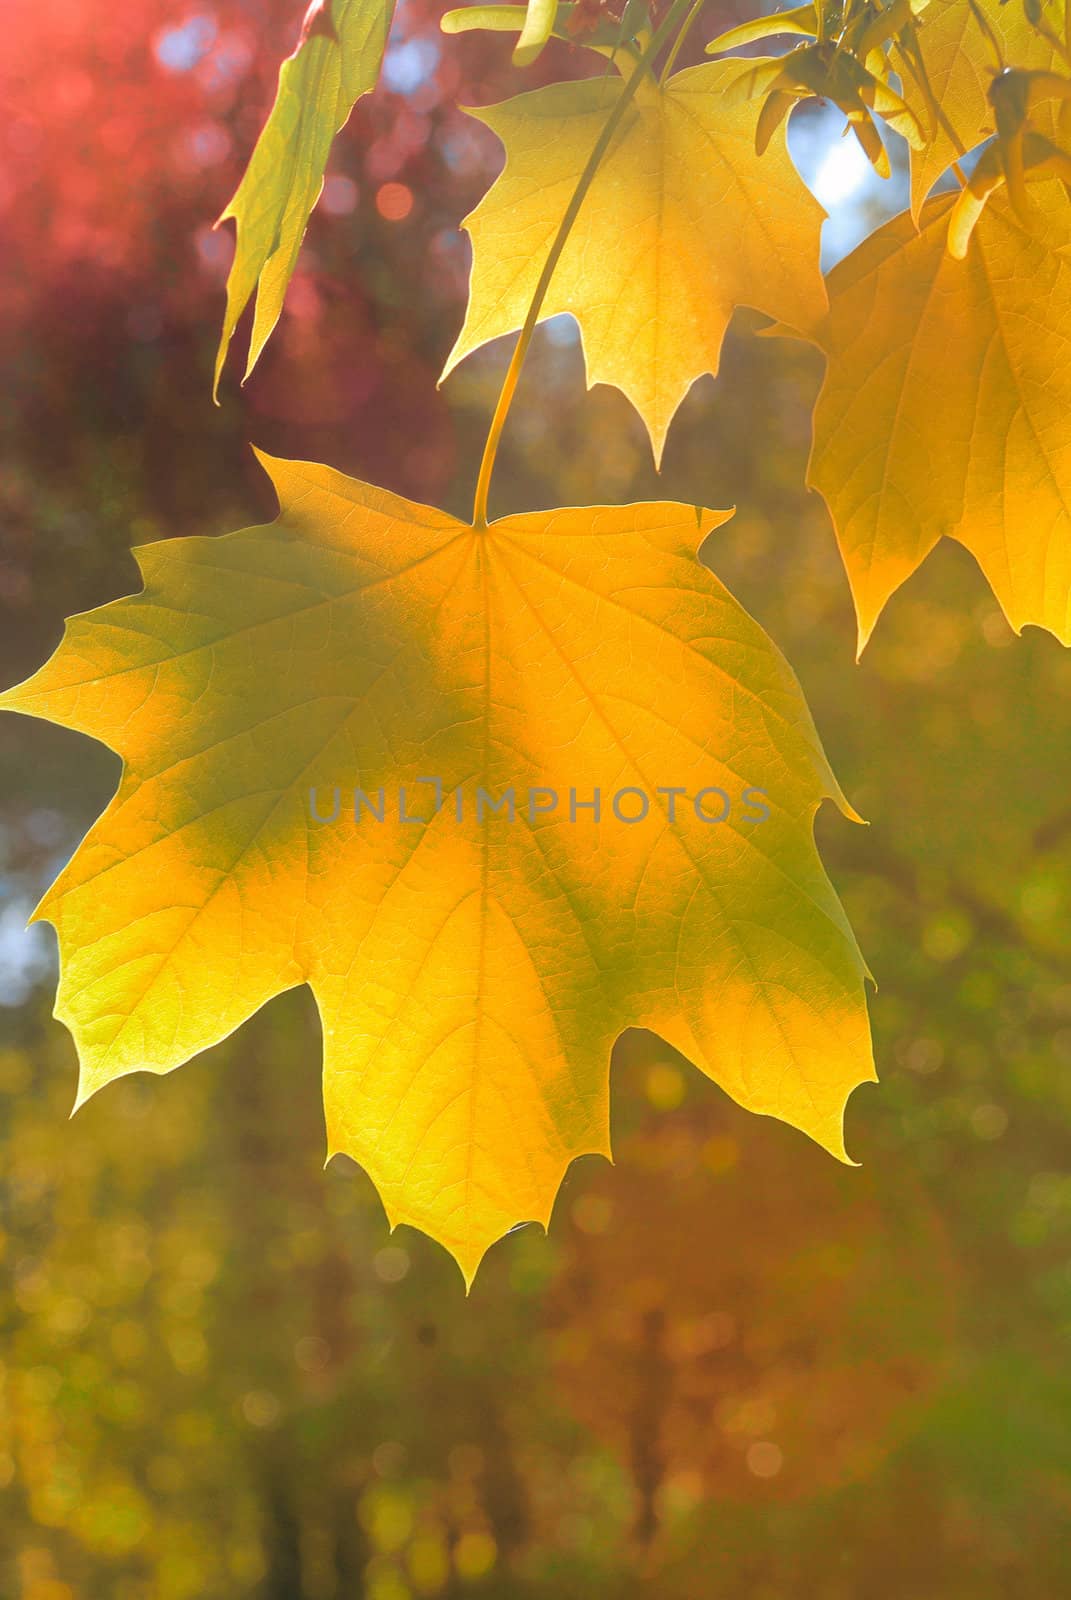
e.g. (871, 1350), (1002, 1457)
(3, 0), (1071, 1277)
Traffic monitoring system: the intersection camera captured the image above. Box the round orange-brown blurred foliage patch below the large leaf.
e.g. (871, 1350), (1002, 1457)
(548, 1102), (956, 1539)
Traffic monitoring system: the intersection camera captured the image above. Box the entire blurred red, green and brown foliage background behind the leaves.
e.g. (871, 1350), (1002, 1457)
(0, 0), (1071, 1600)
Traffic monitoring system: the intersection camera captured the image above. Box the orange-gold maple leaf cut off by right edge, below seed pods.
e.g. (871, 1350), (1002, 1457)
(808, 182), (1071, 650)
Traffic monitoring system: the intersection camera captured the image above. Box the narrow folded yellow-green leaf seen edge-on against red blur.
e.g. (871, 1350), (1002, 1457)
(215, 0), (394, 389)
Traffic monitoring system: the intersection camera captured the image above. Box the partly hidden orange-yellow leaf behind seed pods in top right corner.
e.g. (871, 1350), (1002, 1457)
(900, 0), (1063, 221)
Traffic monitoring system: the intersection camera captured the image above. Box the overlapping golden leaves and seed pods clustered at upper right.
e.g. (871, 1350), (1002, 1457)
(447, 0), (1071, 645)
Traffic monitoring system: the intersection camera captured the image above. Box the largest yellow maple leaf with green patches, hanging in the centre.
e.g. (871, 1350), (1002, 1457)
(0, 461), (872, 1277)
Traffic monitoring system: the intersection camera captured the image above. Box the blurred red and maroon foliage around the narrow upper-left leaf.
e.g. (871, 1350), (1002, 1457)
(0, 0), (509, 525)
